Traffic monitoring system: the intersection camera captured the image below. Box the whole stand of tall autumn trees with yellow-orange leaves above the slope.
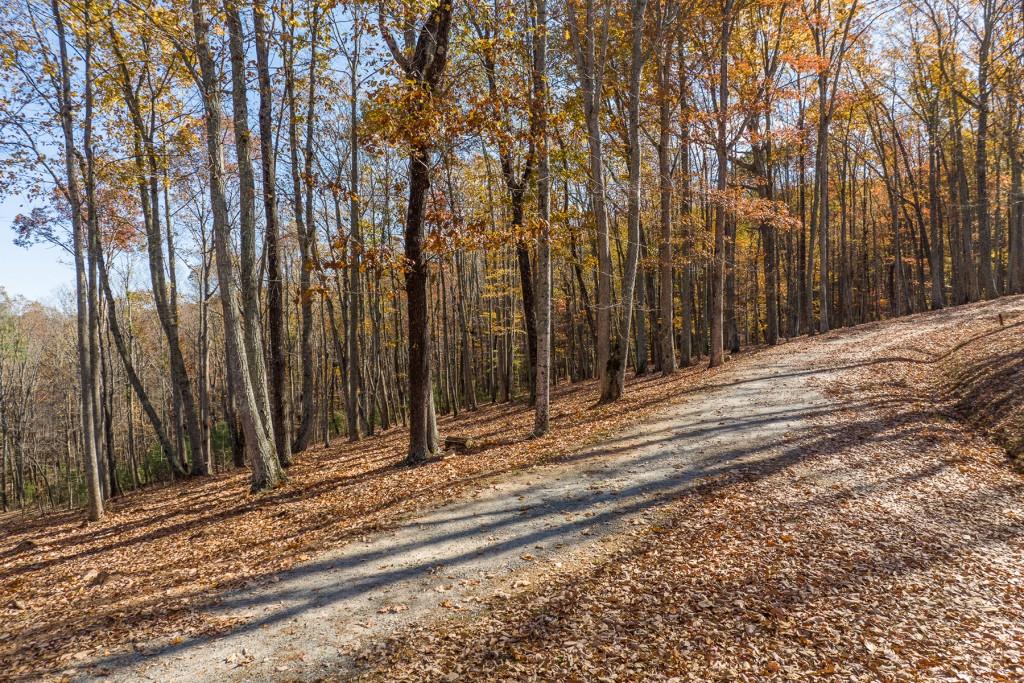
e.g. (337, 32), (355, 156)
(0, 0), (1024, 519)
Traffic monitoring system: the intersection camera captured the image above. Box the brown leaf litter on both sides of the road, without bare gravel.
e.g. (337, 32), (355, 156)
(0, 297), (1024, 680)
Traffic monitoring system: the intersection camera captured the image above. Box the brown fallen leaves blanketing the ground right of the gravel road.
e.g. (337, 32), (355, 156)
(364, 297), (1024, 681)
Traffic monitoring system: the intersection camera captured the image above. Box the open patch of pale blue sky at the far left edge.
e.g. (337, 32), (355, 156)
(0, 197), (75, 304)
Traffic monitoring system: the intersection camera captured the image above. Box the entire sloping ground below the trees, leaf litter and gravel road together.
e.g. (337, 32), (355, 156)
(0, 297), (1024, 681)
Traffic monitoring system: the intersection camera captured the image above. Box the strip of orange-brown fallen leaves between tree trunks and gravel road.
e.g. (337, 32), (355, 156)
(0, 354), (750, 679)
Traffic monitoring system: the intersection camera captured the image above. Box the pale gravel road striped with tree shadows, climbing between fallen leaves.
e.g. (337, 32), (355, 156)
(90, 301), (1024, 681)
